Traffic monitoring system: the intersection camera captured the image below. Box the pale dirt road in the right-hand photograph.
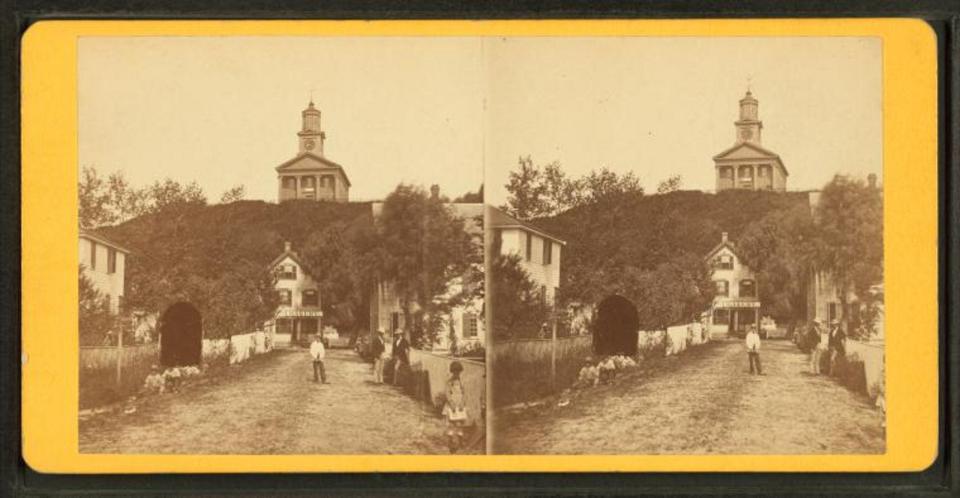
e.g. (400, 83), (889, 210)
(494, 340), (884, 454)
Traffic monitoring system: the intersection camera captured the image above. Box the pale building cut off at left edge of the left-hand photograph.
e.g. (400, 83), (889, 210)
(80, 228), (130, 313)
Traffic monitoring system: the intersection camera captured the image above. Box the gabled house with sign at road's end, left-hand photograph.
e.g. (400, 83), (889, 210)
(268, 242), (323, 344)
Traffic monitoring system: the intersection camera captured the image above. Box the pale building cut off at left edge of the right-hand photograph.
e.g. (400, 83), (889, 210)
(487, 206), (566, 306)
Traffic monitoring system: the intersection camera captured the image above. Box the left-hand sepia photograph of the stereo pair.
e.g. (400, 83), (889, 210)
(77, 37), (486, 455)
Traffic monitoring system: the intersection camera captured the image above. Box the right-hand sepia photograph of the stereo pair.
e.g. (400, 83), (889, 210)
(484, 37), (884, 455)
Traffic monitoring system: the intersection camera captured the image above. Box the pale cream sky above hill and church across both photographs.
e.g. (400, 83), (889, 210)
(79, 37), (882, 204)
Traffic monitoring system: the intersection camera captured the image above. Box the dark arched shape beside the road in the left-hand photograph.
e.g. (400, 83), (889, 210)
(160, 302), (203, 367)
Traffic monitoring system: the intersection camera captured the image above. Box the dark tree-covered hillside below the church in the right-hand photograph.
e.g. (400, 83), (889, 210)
(534, 190), (810, 328)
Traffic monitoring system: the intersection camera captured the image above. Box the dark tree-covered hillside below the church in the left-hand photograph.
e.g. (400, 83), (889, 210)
(99, 201), (373, 336)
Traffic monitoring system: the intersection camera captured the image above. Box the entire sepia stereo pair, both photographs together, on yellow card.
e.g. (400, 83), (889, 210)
(71, 36), (887, 455)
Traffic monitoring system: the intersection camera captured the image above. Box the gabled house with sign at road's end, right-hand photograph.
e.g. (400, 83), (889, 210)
(704, 232), (760, 337)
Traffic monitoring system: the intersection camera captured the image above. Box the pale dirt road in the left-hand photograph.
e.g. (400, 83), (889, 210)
(80, 350), (456, 454)
